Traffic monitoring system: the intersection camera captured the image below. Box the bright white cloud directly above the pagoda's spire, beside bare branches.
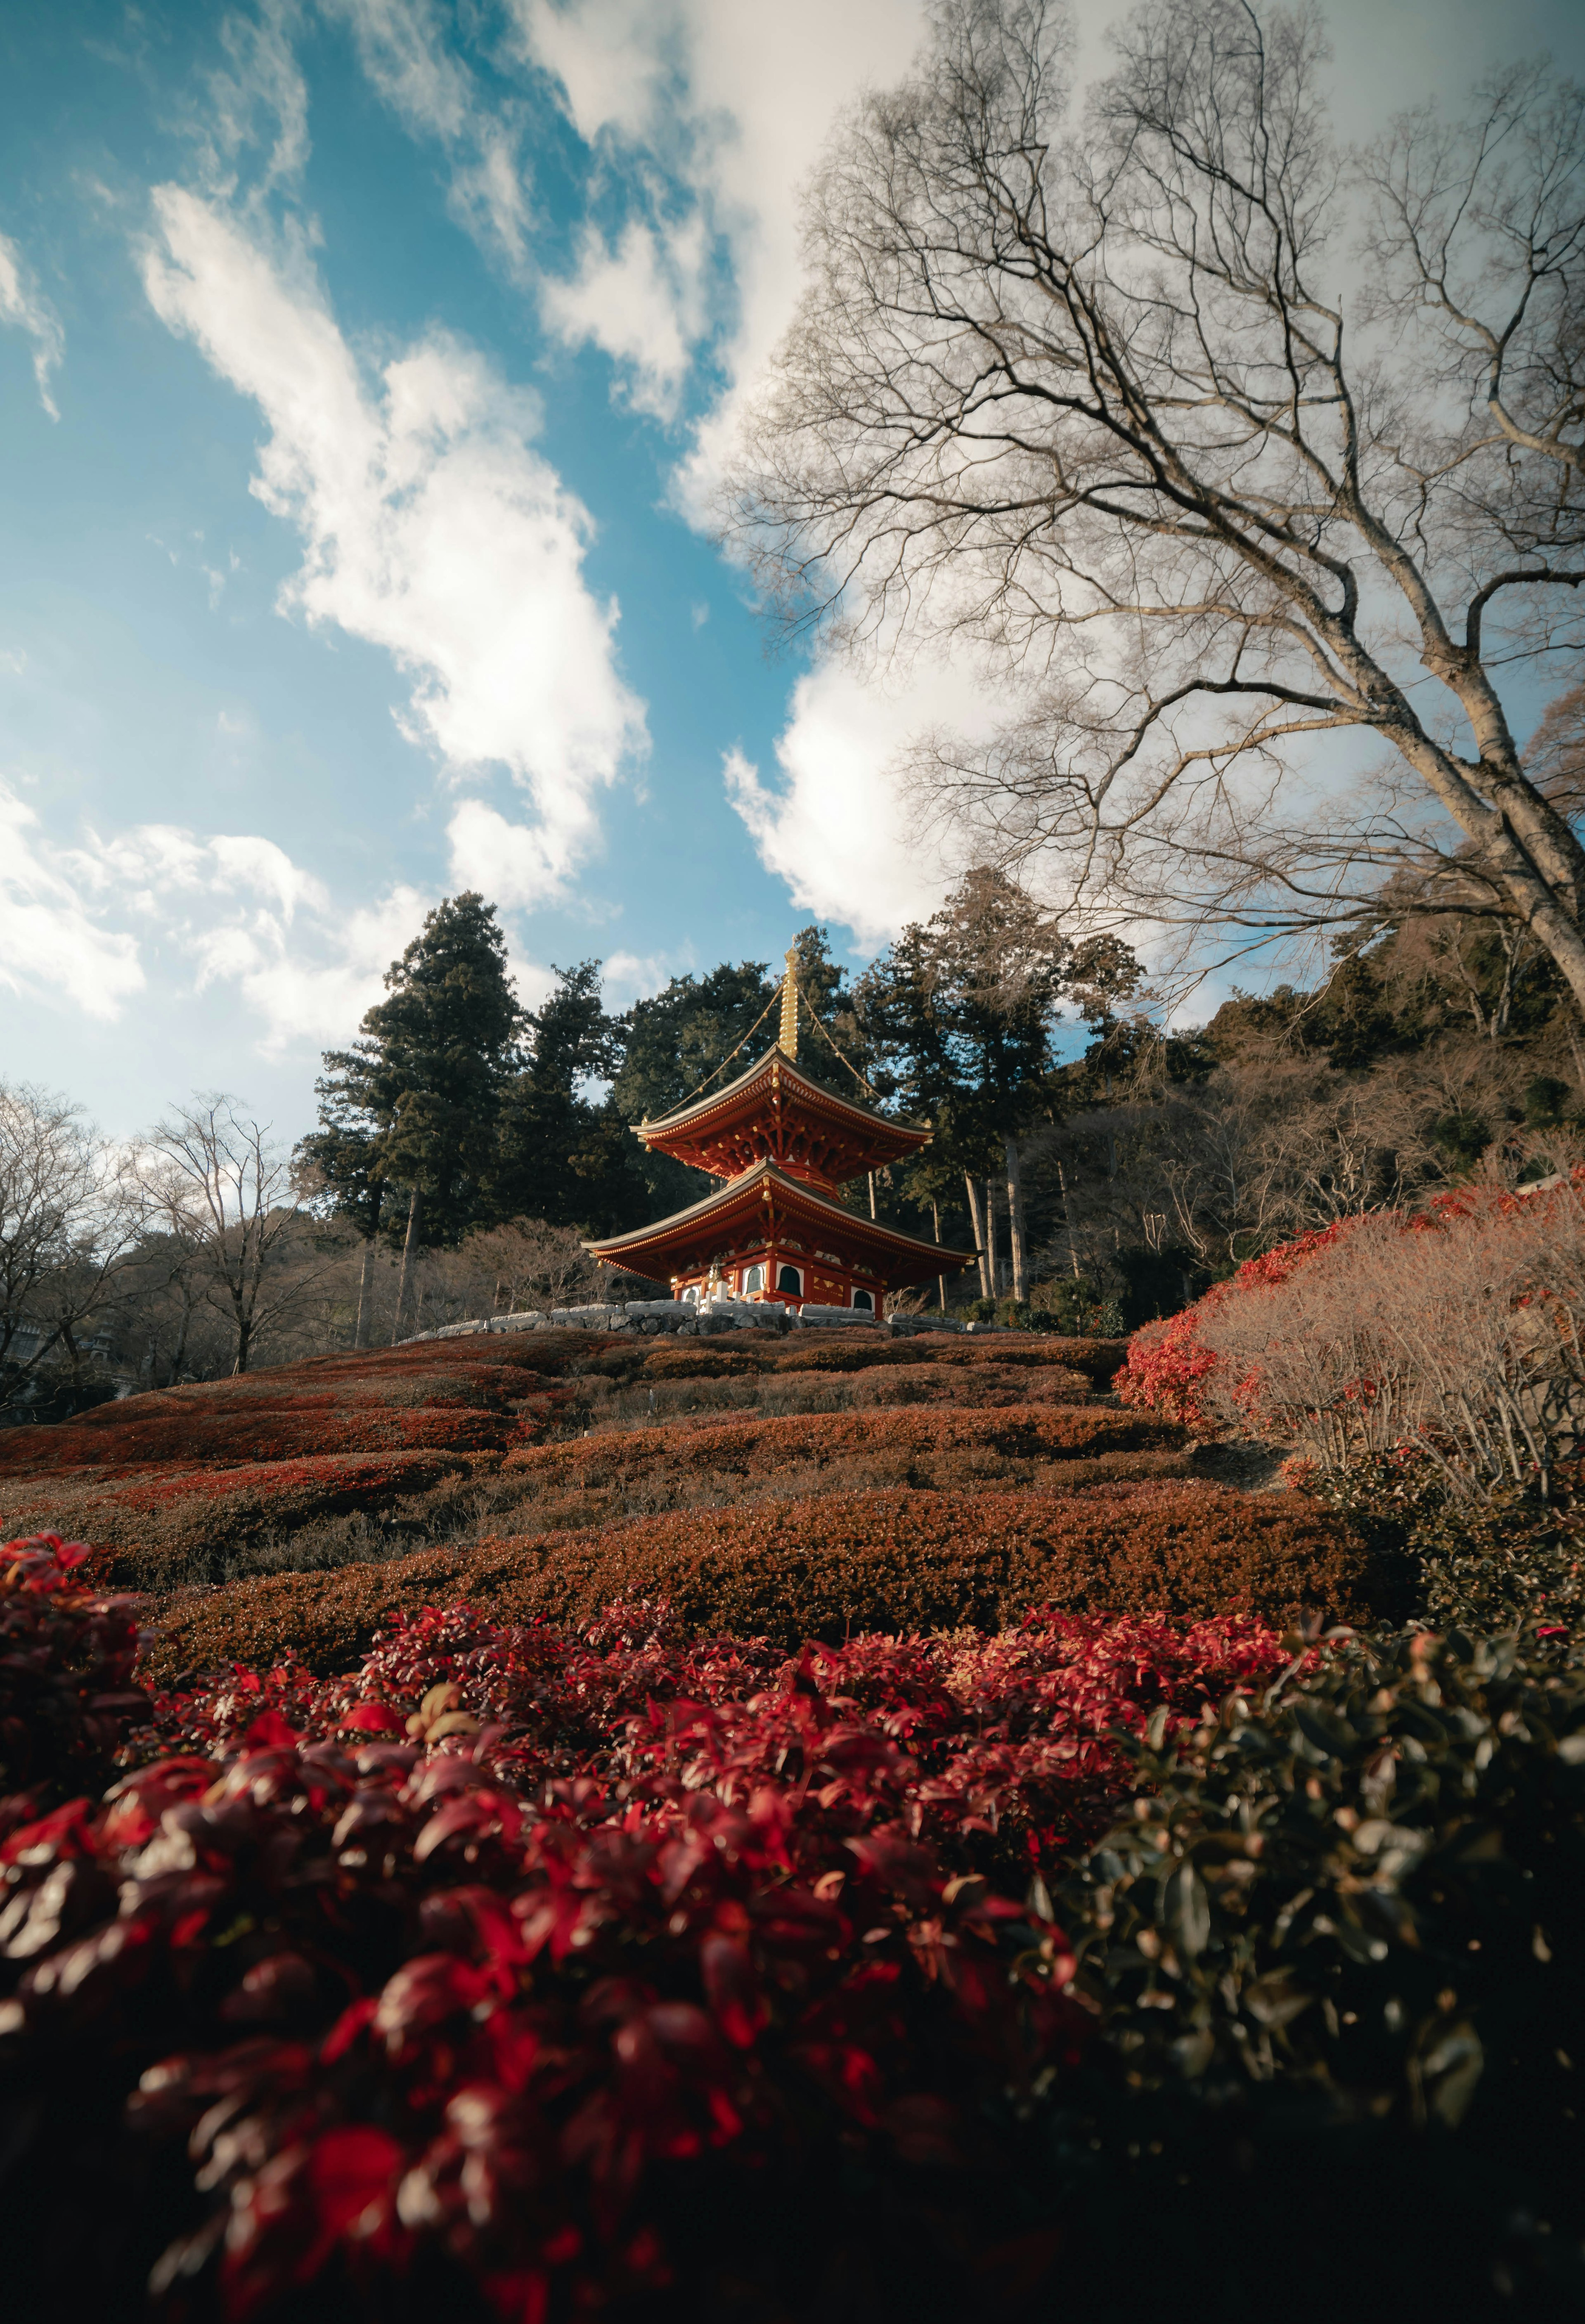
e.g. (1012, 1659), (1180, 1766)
(723, 665), (985, 951)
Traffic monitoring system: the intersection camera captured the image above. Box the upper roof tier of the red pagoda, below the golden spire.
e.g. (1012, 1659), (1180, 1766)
(634, 1044), (930, 1215)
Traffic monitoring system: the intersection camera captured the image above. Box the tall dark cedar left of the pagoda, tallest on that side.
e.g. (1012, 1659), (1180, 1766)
(305, 890), (523, 1332)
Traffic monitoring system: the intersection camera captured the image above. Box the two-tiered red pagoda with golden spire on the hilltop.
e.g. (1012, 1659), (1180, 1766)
(586, 953), (974, 1318)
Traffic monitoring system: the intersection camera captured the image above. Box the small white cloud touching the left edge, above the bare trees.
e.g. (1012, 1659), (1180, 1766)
(0, 786), (144, 1022)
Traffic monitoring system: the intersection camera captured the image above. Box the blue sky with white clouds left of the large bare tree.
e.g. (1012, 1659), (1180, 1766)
(0, 0), (1585, 1136)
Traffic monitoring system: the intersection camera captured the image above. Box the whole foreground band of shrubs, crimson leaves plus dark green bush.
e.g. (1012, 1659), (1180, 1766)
(0, 1541), (1585, 2324)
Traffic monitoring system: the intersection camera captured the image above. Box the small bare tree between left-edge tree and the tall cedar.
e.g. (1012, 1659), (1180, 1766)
(137, 1095), (307, 1373)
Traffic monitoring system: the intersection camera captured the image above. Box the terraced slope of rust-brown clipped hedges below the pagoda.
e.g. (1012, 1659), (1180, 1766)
(0, 1332), (1369, 1671)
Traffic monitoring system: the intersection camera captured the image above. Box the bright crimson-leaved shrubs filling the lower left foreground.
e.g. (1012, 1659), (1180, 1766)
(0, 1545), (1283, 2324)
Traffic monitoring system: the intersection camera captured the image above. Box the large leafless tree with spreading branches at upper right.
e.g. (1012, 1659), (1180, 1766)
(727, 0), (1585, 1008)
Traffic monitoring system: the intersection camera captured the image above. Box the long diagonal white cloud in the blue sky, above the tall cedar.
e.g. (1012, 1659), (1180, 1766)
(144, 186), (646, 902)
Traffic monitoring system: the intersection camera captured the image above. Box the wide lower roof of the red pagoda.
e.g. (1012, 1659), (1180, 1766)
(583, 1162), (974, 1290)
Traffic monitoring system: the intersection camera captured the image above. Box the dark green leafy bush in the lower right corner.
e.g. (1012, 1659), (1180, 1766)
(1055, 1634), (1585, 2319)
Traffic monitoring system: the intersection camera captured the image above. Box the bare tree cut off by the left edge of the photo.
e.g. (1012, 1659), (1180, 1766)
(0, 1083), (142, 1408)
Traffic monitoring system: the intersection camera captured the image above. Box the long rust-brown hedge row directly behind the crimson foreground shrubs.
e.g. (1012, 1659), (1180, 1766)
(142, 1483), (1371, 1673)
